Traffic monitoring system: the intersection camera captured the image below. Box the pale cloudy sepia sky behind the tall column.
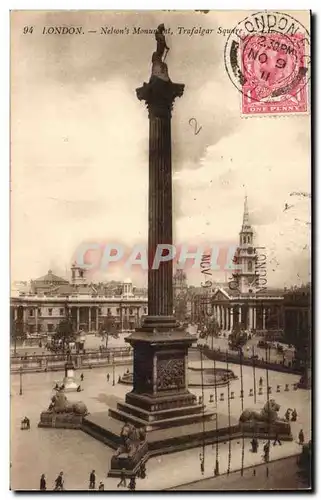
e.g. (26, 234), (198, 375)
(11, 11), (311, 287)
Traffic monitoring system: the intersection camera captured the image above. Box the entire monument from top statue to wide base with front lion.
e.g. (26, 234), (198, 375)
(82, 25), (220, 464)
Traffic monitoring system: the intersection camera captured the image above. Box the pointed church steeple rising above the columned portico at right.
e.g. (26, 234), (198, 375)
(234, 196), (256, 294)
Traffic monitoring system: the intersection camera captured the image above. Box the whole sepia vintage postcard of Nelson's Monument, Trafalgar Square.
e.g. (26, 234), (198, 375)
(10, 10), (313, 492)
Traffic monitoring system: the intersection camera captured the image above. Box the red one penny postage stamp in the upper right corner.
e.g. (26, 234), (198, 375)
(240, 32), (308, 115)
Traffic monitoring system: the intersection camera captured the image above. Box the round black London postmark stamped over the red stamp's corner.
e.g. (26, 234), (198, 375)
(224, 11), (310, 104)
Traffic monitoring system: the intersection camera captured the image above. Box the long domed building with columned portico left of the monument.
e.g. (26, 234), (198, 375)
(10, 264), (147, 334)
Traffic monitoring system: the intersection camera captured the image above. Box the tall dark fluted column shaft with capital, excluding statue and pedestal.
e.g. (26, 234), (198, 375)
(136, 78), (184, 325)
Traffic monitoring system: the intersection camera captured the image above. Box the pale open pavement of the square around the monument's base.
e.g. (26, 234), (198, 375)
(11, 361), (311, 491)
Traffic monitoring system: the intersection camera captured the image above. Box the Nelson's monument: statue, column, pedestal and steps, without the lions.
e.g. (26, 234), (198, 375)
(110, 25), (213, 449)
